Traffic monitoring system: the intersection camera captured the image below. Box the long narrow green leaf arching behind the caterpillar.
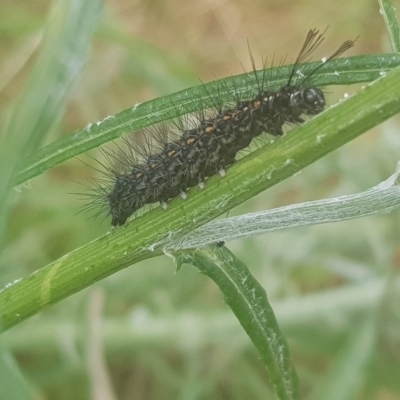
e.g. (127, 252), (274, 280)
(12, 54), (400, 185)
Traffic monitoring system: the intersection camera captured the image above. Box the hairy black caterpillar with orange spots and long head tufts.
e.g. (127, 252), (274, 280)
(83, 29), (354, 228)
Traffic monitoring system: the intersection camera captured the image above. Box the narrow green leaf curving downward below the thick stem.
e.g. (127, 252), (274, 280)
(173, 246), (299, 400)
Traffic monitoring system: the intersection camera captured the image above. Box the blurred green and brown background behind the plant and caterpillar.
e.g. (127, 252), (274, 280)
(0, 0), (400, 400)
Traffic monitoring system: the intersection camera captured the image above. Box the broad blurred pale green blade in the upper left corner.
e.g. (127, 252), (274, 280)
(0, 0), (102, 236)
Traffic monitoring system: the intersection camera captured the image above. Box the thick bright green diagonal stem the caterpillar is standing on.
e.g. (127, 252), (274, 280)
(0, 63), (400, 330)
